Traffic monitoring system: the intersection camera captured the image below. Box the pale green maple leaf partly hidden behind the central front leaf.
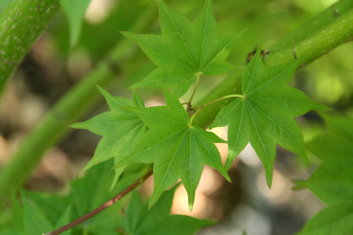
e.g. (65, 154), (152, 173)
(72, 88), (146, 186)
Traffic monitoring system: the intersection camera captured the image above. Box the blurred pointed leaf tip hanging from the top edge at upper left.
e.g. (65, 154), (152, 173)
(60, 0), (91, 47)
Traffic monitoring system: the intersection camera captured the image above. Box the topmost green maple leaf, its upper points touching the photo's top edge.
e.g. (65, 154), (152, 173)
(123, 0), (234, 96)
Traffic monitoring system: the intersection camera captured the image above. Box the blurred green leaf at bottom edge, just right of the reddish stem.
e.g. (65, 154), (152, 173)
(123, 187), (213, 235)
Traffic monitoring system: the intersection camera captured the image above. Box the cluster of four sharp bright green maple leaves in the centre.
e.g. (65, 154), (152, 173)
(74, 0), (323, 208)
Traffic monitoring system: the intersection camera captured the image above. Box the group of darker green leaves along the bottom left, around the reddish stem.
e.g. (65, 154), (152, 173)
(0, 162), (208, 235)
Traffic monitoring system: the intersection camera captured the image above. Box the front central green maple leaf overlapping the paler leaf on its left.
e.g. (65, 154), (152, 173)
(117, 95), (229, 207)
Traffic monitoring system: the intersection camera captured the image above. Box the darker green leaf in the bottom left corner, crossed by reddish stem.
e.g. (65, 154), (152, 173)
(0, 162), (128, 235)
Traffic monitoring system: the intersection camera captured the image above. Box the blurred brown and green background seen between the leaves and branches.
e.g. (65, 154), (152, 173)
(0, 0), (353, 235)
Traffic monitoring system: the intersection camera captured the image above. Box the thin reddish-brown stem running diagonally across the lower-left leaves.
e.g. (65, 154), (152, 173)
(46, 170), (152, 235)
